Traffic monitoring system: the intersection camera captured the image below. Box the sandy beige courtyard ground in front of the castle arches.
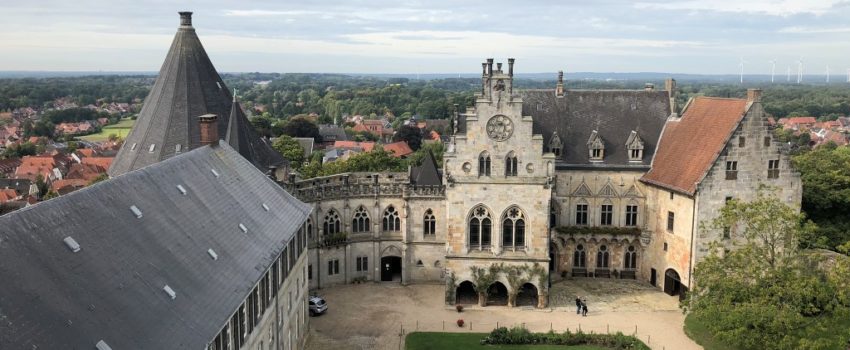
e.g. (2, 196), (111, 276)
(307, 278), (701, 350)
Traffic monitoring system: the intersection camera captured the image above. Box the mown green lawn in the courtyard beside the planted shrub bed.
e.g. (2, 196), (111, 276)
(404, 332), (606, 350)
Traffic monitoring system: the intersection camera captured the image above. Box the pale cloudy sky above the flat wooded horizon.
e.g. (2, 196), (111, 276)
(0, 0), (850, 76)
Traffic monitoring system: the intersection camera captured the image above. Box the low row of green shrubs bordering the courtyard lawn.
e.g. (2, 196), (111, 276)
(481, 327), (649, 350)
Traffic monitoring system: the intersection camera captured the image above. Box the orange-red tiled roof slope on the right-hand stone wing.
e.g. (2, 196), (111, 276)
(641, 97), (747, 195)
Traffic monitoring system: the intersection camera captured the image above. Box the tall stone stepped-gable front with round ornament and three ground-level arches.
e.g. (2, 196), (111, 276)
(444, 58), (555, 304)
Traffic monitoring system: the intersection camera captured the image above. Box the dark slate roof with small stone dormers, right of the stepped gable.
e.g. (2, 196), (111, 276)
(520, 90), (670, 168)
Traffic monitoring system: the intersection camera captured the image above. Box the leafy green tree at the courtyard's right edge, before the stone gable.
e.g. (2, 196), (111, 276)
(683, 189), (850, 349)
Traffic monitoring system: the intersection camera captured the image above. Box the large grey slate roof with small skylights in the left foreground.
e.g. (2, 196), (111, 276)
(0, 143), (311, 349)
